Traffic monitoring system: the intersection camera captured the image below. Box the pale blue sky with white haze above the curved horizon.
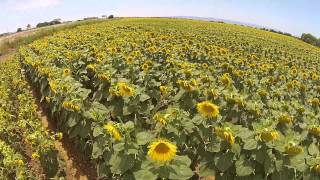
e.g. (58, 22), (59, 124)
(0, 0), (320, 37)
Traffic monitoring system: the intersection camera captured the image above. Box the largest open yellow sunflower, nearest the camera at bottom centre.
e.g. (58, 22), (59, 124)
(148, 139), (177, 163)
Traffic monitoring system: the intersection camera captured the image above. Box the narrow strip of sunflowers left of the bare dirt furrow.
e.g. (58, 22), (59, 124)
(0, 57), (63, 179)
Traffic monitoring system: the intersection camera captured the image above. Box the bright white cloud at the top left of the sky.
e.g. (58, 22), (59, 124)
(7, 0), (60, 11)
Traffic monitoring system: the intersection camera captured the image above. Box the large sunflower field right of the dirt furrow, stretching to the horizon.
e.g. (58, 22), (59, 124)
(15, 18), (320, 180)
